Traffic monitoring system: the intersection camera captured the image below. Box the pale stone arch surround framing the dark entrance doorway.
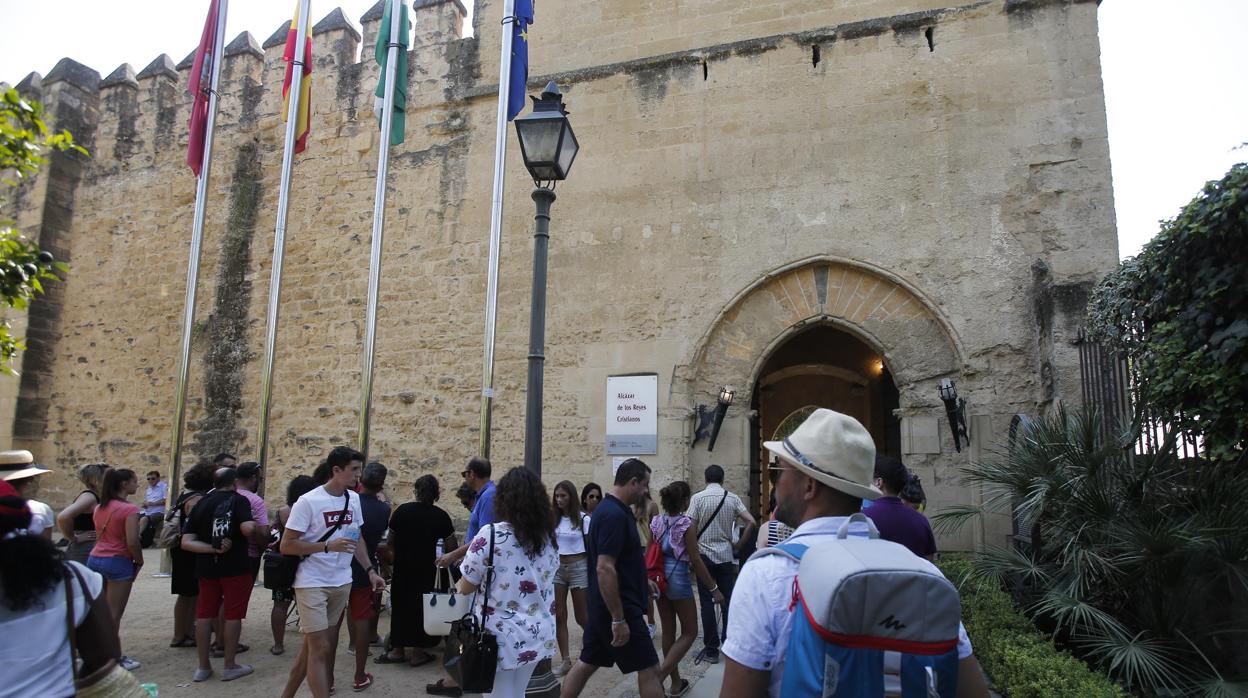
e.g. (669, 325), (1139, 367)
(671, 256), (965, 511)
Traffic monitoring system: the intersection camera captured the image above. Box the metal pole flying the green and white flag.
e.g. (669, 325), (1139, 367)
(356, 0), (407, 462)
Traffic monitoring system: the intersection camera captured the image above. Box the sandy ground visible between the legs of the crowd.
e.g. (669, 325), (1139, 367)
(121, 549), (719, 698)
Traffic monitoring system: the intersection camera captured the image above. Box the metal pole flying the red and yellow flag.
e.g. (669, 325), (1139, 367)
(256, 0), (312, 468)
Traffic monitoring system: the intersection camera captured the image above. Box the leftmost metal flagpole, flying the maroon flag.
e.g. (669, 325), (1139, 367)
(168, 0), (230, 489)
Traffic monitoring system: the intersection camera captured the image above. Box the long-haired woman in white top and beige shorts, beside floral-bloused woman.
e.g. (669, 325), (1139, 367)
(550, 479), (589, 677)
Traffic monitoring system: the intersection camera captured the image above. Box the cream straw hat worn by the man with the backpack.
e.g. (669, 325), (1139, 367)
(763, 408), (884, 499)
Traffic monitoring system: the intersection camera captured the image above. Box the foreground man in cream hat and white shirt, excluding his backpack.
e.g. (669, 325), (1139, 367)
(720, 410), (988, 698)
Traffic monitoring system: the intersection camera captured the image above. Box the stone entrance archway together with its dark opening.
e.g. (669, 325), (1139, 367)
(670, 256), (963, 511)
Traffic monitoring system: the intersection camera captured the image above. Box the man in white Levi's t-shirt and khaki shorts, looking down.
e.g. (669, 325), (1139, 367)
(281, 446), (386, 698)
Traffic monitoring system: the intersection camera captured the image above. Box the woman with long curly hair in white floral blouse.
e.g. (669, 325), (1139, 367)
(459, 468), (559, 698)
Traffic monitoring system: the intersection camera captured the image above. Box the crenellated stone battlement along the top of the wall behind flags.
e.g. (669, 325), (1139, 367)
(17, 0), (479, 175)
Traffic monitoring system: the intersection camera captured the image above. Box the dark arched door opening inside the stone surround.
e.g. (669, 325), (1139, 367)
(750, 325), (901, 513)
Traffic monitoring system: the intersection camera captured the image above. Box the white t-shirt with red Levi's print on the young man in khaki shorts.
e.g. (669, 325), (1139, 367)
(286, 486), (364, 589)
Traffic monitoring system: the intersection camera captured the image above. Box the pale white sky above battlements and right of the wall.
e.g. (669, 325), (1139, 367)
(0, 0), (1248, 257)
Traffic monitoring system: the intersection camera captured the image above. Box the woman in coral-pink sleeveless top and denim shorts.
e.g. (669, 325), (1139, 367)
(86, 468), (144, 672)
